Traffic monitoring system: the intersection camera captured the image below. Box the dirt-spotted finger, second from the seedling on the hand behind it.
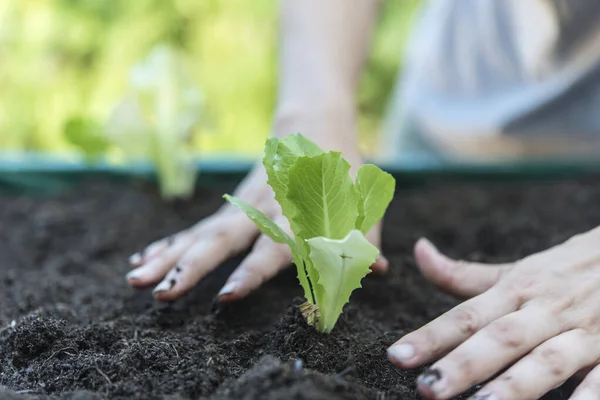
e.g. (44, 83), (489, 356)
(152, 235), (232, 301)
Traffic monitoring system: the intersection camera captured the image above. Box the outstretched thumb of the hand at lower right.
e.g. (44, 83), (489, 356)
(414, 238), (512, 298)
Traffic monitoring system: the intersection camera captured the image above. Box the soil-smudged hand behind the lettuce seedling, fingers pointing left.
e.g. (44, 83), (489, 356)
(127, 133), (388, 301)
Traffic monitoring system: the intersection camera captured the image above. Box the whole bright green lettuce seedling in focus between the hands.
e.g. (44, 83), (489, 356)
(224, 134), (395, 333)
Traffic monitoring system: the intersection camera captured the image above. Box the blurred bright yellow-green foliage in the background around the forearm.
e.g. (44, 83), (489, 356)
(0, 0), (420, 159)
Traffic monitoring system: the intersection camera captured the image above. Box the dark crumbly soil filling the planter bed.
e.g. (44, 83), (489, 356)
(0, 180), (600, 399)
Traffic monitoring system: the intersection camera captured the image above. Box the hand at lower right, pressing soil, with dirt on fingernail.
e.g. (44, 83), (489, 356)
(388, 228), (600, 400)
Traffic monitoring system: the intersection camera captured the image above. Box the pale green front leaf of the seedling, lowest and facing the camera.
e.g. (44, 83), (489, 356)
(307, 229), (379, 333)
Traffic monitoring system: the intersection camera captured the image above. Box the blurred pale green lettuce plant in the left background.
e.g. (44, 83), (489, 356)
(105, 45), (203, 199)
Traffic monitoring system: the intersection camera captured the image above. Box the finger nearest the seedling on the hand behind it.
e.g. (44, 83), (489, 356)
(219, 236), (292, 301)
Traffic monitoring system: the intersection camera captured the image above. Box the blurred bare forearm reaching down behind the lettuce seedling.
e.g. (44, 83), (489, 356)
(275, 0), (380, 147)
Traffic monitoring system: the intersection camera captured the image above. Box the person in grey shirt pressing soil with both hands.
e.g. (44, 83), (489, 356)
(127, 0), (600, 400)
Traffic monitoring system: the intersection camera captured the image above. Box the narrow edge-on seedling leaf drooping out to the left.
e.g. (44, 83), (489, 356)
(223, 194), (314, 302)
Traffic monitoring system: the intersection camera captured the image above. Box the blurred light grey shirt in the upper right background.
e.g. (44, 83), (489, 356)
(387, 0), (600, 161)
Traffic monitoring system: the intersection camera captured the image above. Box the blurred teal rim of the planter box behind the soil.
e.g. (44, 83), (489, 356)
(0, 153), (600, 196)
